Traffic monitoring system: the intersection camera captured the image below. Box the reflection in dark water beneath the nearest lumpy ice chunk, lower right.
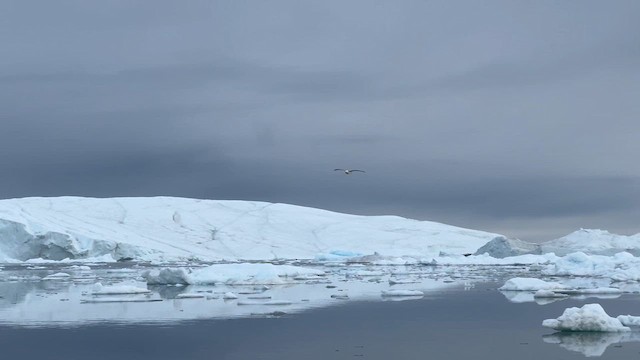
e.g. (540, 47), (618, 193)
(542, 331), (640, 357)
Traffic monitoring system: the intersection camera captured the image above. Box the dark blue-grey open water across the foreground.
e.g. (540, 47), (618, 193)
(0, 284), (640, 360)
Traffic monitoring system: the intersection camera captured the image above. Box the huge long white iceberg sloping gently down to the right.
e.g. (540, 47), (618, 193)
(0, 197), (500, 262)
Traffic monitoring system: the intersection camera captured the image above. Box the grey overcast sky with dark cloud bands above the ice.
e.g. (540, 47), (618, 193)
(0, 0), (640, 241)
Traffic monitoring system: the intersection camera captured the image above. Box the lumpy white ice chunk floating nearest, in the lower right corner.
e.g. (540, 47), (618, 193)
(542, 304), (631, 332)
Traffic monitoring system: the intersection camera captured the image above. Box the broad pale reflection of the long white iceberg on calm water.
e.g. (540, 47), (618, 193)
(0, 266), (456, 326)
